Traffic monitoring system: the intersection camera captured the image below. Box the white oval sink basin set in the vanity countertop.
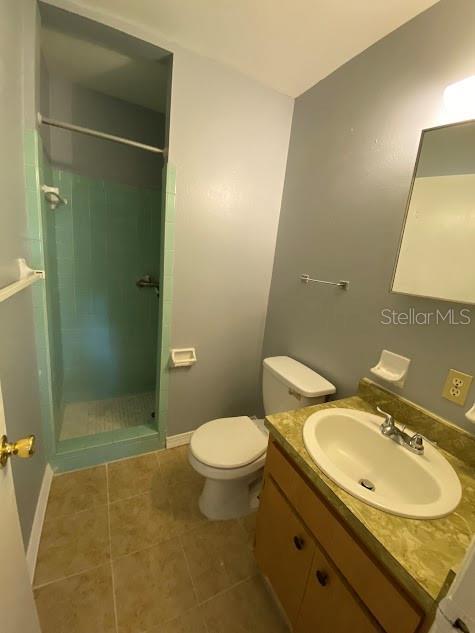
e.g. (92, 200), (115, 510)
(303, 408), (462, 519)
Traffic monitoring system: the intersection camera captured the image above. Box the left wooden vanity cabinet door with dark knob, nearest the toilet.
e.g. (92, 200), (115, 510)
(256, 478), (315, 626)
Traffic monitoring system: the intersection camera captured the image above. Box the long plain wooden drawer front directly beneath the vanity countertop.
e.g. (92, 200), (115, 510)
(266, 441), (421, 633)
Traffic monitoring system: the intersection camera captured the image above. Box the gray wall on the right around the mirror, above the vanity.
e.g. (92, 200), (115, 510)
(264, 0), (475, 430)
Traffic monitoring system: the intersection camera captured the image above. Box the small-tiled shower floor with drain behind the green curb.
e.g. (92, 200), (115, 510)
(59, 391), (155, 440)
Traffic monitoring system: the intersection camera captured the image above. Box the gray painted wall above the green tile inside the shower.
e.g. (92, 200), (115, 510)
(41, 72), (165, 189)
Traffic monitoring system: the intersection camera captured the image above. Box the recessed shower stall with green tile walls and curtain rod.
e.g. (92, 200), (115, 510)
(34, 5), (175, 466)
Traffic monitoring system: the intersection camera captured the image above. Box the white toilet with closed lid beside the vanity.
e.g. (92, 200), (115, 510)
(189, 356), (335, 520)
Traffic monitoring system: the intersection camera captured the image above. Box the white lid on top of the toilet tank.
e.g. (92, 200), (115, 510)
(264, 356), (336, 398)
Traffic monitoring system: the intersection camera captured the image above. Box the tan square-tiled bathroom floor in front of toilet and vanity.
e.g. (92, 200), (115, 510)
(34, 447), (287, 633)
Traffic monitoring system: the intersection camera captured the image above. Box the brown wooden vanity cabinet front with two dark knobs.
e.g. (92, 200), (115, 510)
(255, 441), (424, 633)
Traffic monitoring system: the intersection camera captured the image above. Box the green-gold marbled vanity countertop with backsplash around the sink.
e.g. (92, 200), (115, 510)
(266, 379), (475, 611)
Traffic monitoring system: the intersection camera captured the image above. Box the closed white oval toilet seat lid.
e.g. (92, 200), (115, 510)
(190, 416), (268, 469)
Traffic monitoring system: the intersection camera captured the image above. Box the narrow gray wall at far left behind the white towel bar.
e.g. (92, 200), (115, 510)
(0, 0), (45, 546)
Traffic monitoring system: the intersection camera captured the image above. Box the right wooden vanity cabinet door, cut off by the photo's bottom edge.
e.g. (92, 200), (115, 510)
(295, 545), (382, 633)
